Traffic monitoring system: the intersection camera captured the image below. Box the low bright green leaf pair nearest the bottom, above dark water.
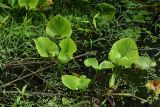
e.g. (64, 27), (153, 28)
(62, 75), (91, 90)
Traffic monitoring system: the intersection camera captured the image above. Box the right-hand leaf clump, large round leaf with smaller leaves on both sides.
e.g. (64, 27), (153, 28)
(84, 38), (156, 70)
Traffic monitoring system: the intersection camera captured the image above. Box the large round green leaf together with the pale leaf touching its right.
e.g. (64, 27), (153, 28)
(109, 38), (156, 70)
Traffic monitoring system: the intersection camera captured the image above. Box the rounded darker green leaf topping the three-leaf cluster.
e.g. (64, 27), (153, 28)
(46, 15), (72, 38)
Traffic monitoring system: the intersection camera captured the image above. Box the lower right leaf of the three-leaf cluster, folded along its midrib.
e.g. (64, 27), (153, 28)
(58, 37), (77, 63)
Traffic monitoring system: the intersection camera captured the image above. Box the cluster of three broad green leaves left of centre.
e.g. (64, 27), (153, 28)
(34, 15), (77, 63)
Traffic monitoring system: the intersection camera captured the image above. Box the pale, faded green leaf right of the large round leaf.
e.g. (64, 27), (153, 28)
(135, 56), (156, 70)
